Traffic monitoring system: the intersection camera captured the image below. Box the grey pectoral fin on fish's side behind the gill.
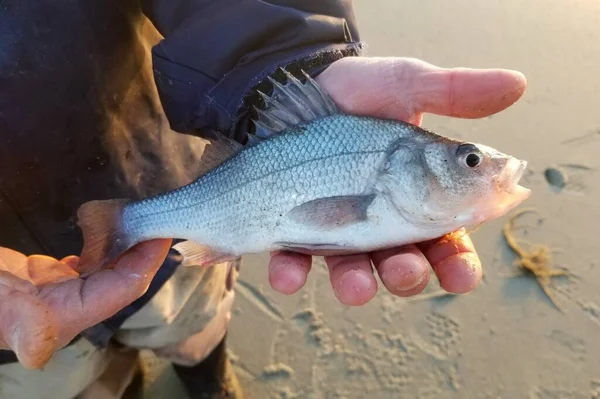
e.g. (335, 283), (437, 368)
(288, 194), (375, 228)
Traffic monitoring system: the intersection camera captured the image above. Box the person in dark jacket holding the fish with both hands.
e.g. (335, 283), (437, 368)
(0, 0), (526, 398)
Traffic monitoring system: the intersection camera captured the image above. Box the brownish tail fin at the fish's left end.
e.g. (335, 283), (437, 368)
(77, 199), (135, 274)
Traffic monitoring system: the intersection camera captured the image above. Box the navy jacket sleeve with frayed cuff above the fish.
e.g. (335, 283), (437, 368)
(142, 0), (362, 142)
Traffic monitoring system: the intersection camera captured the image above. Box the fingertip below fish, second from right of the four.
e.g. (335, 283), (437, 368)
(371, 245), (430, 297)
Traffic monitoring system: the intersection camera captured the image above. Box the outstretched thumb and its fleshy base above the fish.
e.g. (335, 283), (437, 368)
(317, 57), (527, 121)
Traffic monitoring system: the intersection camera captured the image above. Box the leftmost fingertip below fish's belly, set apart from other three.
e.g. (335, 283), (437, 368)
(269, 251), (312, 295)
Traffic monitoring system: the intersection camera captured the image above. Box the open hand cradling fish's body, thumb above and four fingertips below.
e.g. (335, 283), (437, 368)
(269, 57), (527, 306)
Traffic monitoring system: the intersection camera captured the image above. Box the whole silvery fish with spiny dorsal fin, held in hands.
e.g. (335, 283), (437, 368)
(77, 68), (531, 273)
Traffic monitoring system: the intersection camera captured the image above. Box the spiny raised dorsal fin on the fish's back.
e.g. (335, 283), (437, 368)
(252, 68), (340, 140)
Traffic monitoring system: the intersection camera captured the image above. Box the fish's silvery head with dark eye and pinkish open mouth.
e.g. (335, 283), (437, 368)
(387, 138), (531, 229)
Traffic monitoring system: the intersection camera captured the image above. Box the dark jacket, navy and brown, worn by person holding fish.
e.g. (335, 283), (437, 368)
(0, 0), (360, 356)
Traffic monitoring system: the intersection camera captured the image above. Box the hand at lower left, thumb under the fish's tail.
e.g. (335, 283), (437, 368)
(0, 240), (171, 369)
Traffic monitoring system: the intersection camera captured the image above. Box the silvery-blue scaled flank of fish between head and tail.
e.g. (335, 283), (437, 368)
(124, 116), (403, 252)
